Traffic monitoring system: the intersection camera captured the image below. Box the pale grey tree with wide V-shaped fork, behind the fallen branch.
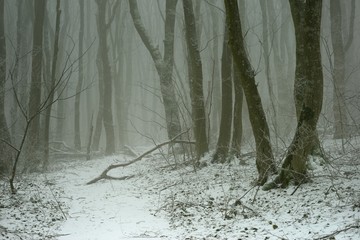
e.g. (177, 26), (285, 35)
(129, 0), (181, 139)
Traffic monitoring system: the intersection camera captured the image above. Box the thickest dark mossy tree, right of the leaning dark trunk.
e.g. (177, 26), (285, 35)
(276, 0), (323, 186)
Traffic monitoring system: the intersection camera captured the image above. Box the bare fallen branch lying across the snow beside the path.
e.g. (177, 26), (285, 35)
(86, 133), (195, 185)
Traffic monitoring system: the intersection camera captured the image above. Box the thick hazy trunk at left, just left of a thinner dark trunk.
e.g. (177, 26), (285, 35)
(25, 0), (46, 171)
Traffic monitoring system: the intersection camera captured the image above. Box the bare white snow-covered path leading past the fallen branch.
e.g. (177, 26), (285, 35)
(52, 159), (169, 240)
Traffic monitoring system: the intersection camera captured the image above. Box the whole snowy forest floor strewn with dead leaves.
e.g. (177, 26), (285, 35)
(0, 138), (360, 240)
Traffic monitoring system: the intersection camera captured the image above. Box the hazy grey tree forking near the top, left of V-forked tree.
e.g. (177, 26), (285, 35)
(96, 0), (120, 155)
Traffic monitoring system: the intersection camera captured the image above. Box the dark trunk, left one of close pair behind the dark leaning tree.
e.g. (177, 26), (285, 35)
(212, 26), (233, 163)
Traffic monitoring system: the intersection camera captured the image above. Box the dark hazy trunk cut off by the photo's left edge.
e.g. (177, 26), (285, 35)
(0, 0), (11, 174)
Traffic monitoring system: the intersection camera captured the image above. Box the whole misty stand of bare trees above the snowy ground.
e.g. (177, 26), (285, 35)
(0, 0), (360, 191)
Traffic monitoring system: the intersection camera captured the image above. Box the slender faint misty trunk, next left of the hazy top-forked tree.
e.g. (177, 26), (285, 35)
(74, 0), (84, 150)
